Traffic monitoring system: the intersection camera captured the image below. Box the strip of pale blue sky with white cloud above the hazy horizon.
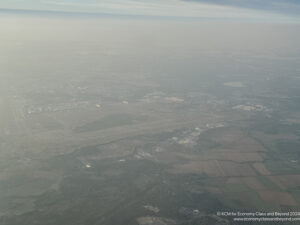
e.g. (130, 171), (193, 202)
(0, 0), (300, 23)
